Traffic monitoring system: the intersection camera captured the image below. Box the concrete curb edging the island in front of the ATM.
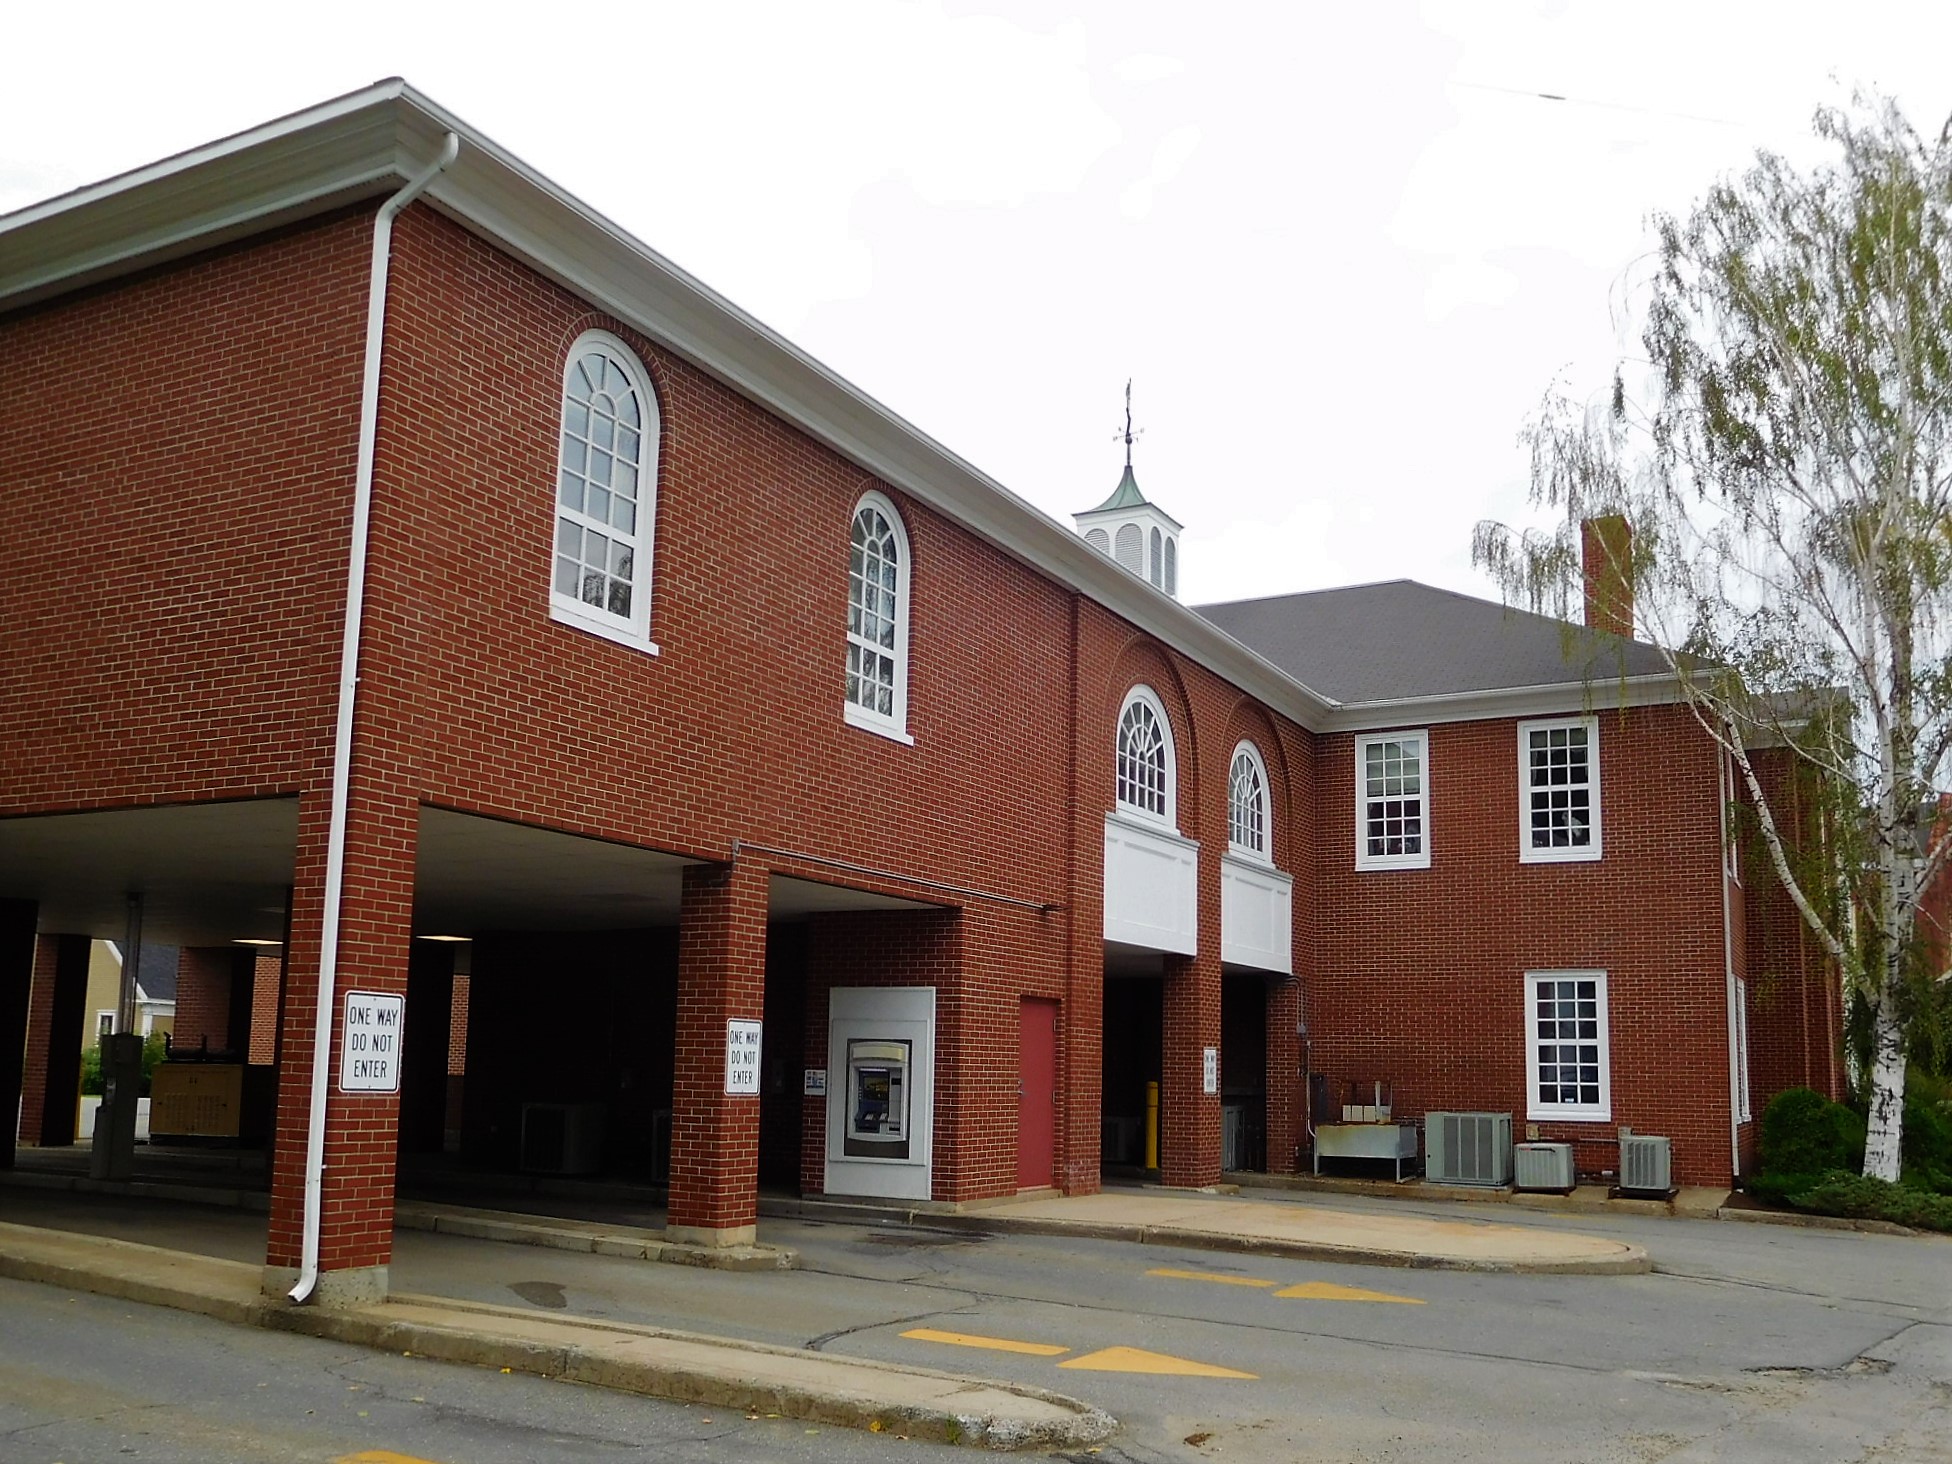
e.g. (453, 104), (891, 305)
(769, 1200), (1653, 1277)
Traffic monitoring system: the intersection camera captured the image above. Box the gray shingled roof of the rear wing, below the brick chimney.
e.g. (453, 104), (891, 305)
(1195, 580), (1667, 703)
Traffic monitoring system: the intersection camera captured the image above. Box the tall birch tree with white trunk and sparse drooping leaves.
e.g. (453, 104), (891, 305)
(1472, 98), (1952, 1181)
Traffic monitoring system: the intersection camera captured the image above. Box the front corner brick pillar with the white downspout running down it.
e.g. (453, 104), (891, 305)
(265, 783), (418, 1306)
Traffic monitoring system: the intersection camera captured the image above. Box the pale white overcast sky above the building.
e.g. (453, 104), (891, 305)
(11, 0), (1952, 601)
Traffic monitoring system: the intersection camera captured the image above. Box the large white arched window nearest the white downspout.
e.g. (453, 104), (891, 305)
(550, 330), (658, 650)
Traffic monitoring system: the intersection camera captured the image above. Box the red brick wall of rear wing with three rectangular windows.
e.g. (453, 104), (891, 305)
(1310, 707), (1731, 1185)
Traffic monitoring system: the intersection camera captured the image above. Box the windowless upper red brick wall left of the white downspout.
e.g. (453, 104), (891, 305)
(0, 215), (371, 812)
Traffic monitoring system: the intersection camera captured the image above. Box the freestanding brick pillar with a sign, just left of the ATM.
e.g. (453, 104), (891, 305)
(668, 865), (767, 1245)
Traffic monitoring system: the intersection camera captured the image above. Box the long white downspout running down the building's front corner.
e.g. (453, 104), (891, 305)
(291, 133), (461, 1302)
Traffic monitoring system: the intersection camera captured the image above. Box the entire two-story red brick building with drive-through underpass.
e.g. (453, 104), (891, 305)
(0, 82), (1835, 1296)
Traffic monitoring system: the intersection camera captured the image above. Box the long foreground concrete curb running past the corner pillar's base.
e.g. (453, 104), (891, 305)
(0, 1224), (1117, 1450)
